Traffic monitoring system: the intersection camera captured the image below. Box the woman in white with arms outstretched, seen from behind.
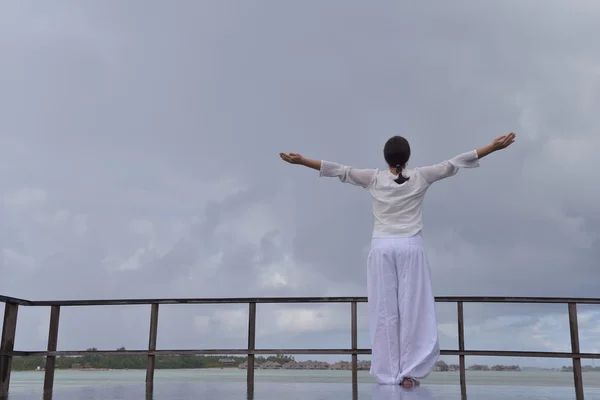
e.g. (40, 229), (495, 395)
(280, 133), (515, 387)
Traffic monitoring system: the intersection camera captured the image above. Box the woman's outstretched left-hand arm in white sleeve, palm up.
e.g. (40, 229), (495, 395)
(279, 153), (377, 188)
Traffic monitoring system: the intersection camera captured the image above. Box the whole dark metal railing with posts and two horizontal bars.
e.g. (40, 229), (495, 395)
(0, 296), (600, 400)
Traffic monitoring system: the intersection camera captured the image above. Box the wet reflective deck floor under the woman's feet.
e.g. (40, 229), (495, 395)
(0, 382), (600, 400)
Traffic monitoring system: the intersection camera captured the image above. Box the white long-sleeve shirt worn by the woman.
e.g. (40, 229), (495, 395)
(319, 150), (479, 237)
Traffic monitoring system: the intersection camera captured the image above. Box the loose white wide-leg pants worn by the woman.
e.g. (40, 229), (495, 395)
(367, 234), (440, 385)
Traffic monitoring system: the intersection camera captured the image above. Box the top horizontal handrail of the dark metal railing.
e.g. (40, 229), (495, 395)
(10, 296), (600, 306)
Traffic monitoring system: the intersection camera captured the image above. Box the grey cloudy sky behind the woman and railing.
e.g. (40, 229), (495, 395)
(0, 0), (600, 372)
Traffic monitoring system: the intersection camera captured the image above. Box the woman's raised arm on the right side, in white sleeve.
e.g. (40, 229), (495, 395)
(417, 133), (516, 184)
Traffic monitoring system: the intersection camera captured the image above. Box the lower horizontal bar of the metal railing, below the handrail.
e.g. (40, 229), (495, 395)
(2, 349), (600, 359)
